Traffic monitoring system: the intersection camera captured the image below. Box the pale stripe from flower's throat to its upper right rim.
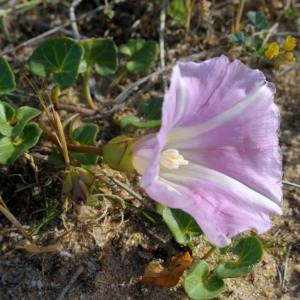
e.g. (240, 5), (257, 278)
(168, 84), (272, 145)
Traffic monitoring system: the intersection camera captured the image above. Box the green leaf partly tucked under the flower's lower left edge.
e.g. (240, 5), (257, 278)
(162, 207), (202, 244)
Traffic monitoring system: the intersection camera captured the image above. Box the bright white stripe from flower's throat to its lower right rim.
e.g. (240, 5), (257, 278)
(160, 162), (281, 215)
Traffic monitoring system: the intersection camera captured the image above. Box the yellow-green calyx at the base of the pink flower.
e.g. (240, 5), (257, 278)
(102, 135), (135, 171)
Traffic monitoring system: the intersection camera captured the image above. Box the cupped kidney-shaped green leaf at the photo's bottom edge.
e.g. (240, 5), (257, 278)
(184, 261), (225, 300)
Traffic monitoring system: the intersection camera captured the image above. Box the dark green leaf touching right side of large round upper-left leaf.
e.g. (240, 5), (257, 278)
(81, 38), (118, 76)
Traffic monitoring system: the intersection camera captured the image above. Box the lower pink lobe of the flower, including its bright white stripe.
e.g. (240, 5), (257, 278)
(147, 164), (281, 247)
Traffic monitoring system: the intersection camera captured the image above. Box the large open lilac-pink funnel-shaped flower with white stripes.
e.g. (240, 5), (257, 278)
(133, 56), (282, 247)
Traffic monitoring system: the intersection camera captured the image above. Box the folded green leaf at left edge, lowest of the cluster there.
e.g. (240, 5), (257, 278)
(0, 123), (42, 165)
